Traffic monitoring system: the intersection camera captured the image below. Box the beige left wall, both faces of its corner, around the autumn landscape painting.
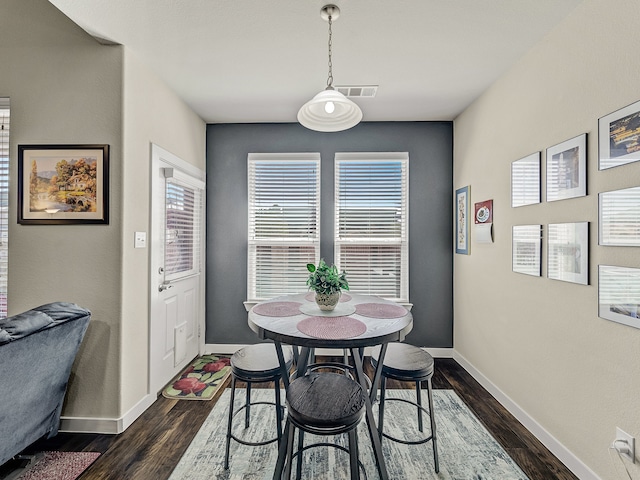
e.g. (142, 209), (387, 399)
(0, 0), (205, 432)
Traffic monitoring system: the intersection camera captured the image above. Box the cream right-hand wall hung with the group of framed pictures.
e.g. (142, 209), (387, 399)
(454, 0), (640, 479)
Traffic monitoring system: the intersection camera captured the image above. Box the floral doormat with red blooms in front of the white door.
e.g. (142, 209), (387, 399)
(162, 355), (231, 400)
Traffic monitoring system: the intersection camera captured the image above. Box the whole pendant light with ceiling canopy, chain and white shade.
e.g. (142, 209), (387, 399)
(298, 5), (362, 132)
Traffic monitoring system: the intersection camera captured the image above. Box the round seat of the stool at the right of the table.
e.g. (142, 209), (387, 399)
(372, 342), (435, 381)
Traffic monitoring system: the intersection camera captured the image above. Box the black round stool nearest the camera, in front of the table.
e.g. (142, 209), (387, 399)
(274, 373), (366, 480)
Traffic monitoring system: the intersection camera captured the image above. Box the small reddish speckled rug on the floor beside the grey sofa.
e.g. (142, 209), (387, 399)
(17, 452), (100, 480)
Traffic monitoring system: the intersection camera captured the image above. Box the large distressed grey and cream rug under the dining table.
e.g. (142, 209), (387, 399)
(170, 389), (527, 480)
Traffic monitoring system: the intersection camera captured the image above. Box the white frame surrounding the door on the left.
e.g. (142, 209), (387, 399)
(148, 143), (206, 395)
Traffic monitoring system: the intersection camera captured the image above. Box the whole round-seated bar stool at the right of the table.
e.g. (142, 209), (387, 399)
(371, 342), (440, 473)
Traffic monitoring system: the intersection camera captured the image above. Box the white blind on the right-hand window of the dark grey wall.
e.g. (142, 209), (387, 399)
(334, 152), (409, 302)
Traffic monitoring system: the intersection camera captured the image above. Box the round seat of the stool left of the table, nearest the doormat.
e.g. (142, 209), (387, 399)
(230, 343), (293, 381)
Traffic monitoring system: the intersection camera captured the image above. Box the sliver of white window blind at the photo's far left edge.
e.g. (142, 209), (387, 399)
(0, 98), (11, 318)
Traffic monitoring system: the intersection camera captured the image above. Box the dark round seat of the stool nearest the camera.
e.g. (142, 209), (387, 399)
(287, 373), (365, 429)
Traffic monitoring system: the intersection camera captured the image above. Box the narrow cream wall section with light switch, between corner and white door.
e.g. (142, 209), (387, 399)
(121, 50), (206, 412)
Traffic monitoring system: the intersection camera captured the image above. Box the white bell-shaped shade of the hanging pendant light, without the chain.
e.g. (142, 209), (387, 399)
(298, 89), (362, 132)
